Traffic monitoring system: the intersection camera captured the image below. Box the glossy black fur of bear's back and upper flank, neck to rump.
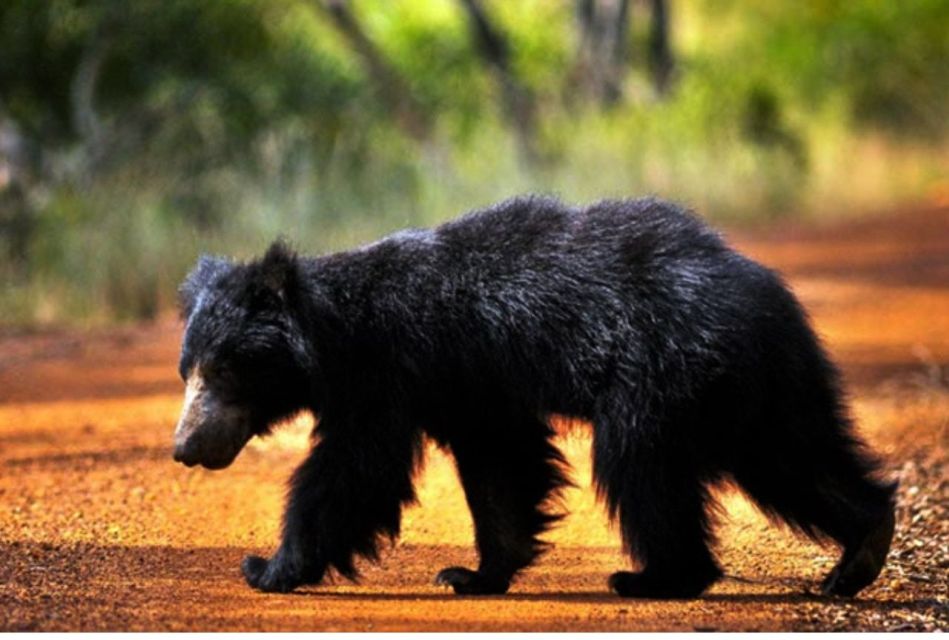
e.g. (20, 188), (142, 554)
(317, 196), (787, 413)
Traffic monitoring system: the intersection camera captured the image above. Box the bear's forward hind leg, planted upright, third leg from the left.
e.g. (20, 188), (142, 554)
(593, 410), (722, 599)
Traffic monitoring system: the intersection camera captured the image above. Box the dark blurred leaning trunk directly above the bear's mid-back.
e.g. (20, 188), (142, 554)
(460, 0), (538, 161)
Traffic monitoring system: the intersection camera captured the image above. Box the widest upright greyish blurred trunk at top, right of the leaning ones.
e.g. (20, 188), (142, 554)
(568, 0), (630, 106)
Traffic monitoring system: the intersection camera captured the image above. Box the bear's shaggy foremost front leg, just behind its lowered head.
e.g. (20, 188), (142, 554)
(241, 419), (419, 593)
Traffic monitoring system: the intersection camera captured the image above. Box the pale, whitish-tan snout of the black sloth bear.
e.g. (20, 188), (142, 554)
(173, 372), (253, 469)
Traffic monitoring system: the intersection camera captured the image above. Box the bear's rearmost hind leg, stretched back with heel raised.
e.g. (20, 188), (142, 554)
(722, 304), (896, 596)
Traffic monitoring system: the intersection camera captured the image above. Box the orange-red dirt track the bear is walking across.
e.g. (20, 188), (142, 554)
(0, 208), (949, 630)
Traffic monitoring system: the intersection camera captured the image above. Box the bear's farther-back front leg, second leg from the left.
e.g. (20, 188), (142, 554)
(435, 415), (569, 595)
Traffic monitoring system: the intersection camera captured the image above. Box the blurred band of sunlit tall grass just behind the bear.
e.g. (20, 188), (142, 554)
(0, 120), (949, 325)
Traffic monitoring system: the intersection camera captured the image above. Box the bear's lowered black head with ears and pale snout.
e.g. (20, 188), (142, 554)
(174, 242), (313, 469)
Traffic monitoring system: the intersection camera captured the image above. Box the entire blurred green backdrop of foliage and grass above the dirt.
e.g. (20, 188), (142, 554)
(0, 0), (949, 322)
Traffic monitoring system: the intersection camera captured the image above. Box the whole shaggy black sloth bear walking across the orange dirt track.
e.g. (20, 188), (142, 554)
(174, 196), (895, 598)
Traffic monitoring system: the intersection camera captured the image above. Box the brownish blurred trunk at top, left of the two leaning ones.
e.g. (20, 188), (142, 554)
(315, 0), (431, 141)
